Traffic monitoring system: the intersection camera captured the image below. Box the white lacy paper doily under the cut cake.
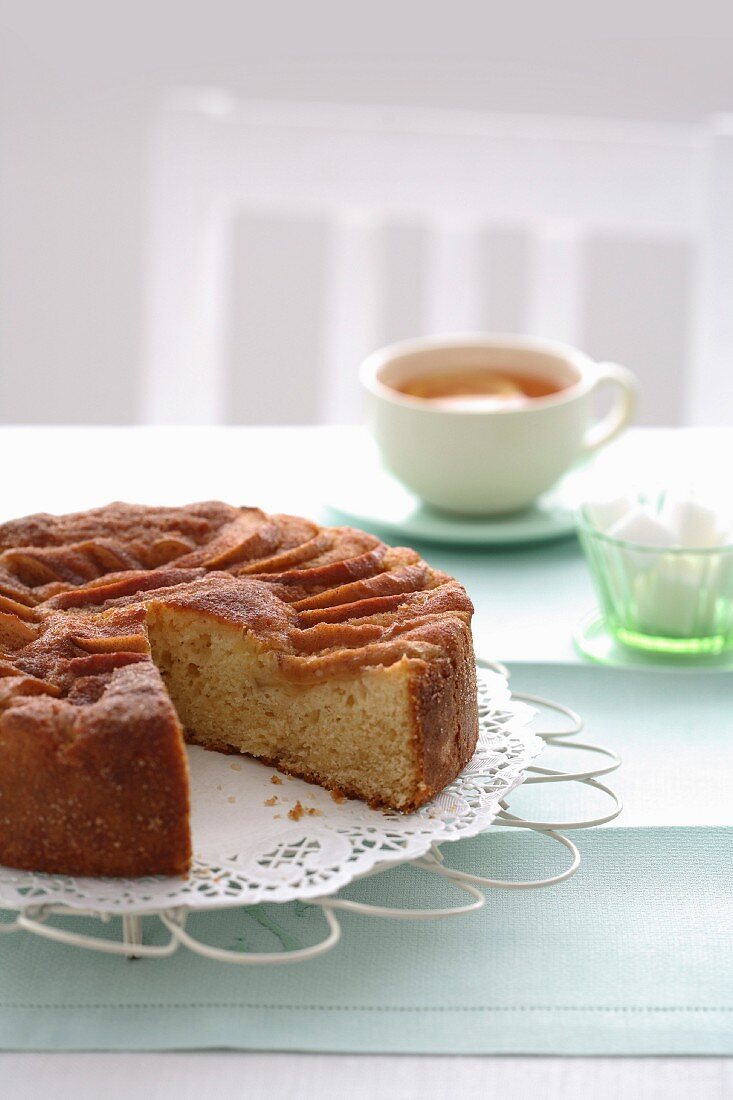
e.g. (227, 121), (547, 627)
(0, 669), (544, 915)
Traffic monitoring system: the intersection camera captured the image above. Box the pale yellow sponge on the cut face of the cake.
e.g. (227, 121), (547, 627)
(147, 602), (418, 809)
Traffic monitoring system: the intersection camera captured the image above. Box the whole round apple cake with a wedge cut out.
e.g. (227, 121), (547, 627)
(0, 502), (478, 876)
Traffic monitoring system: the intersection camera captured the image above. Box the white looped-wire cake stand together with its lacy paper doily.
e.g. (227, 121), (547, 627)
(0, 662), (621, 965)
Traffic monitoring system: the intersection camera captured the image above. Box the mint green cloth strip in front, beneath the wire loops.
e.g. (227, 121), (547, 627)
(0, 828), (733, 1054)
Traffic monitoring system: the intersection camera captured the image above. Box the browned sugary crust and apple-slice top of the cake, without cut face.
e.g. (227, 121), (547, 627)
(0, 502), (478, 876)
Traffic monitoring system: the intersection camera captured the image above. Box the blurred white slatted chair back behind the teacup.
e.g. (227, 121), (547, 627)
(141, 91), (733, 424)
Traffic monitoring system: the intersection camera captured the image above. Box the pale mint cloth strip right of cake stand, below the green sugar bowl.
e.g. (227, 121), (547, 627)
(501, 663), (733, 827)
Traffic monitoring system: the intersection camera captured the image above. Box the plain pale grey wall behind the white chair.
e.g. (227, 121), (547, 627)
(0, 0), (733, 422)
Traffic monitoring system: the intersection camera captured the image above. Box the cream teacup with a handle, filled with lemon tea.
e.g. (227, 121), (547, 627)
(360, 334), (636, 516)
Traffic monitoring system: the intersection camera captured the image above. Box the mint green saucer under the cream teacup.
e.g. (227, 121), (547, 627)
(325, 451), (588, 547)
